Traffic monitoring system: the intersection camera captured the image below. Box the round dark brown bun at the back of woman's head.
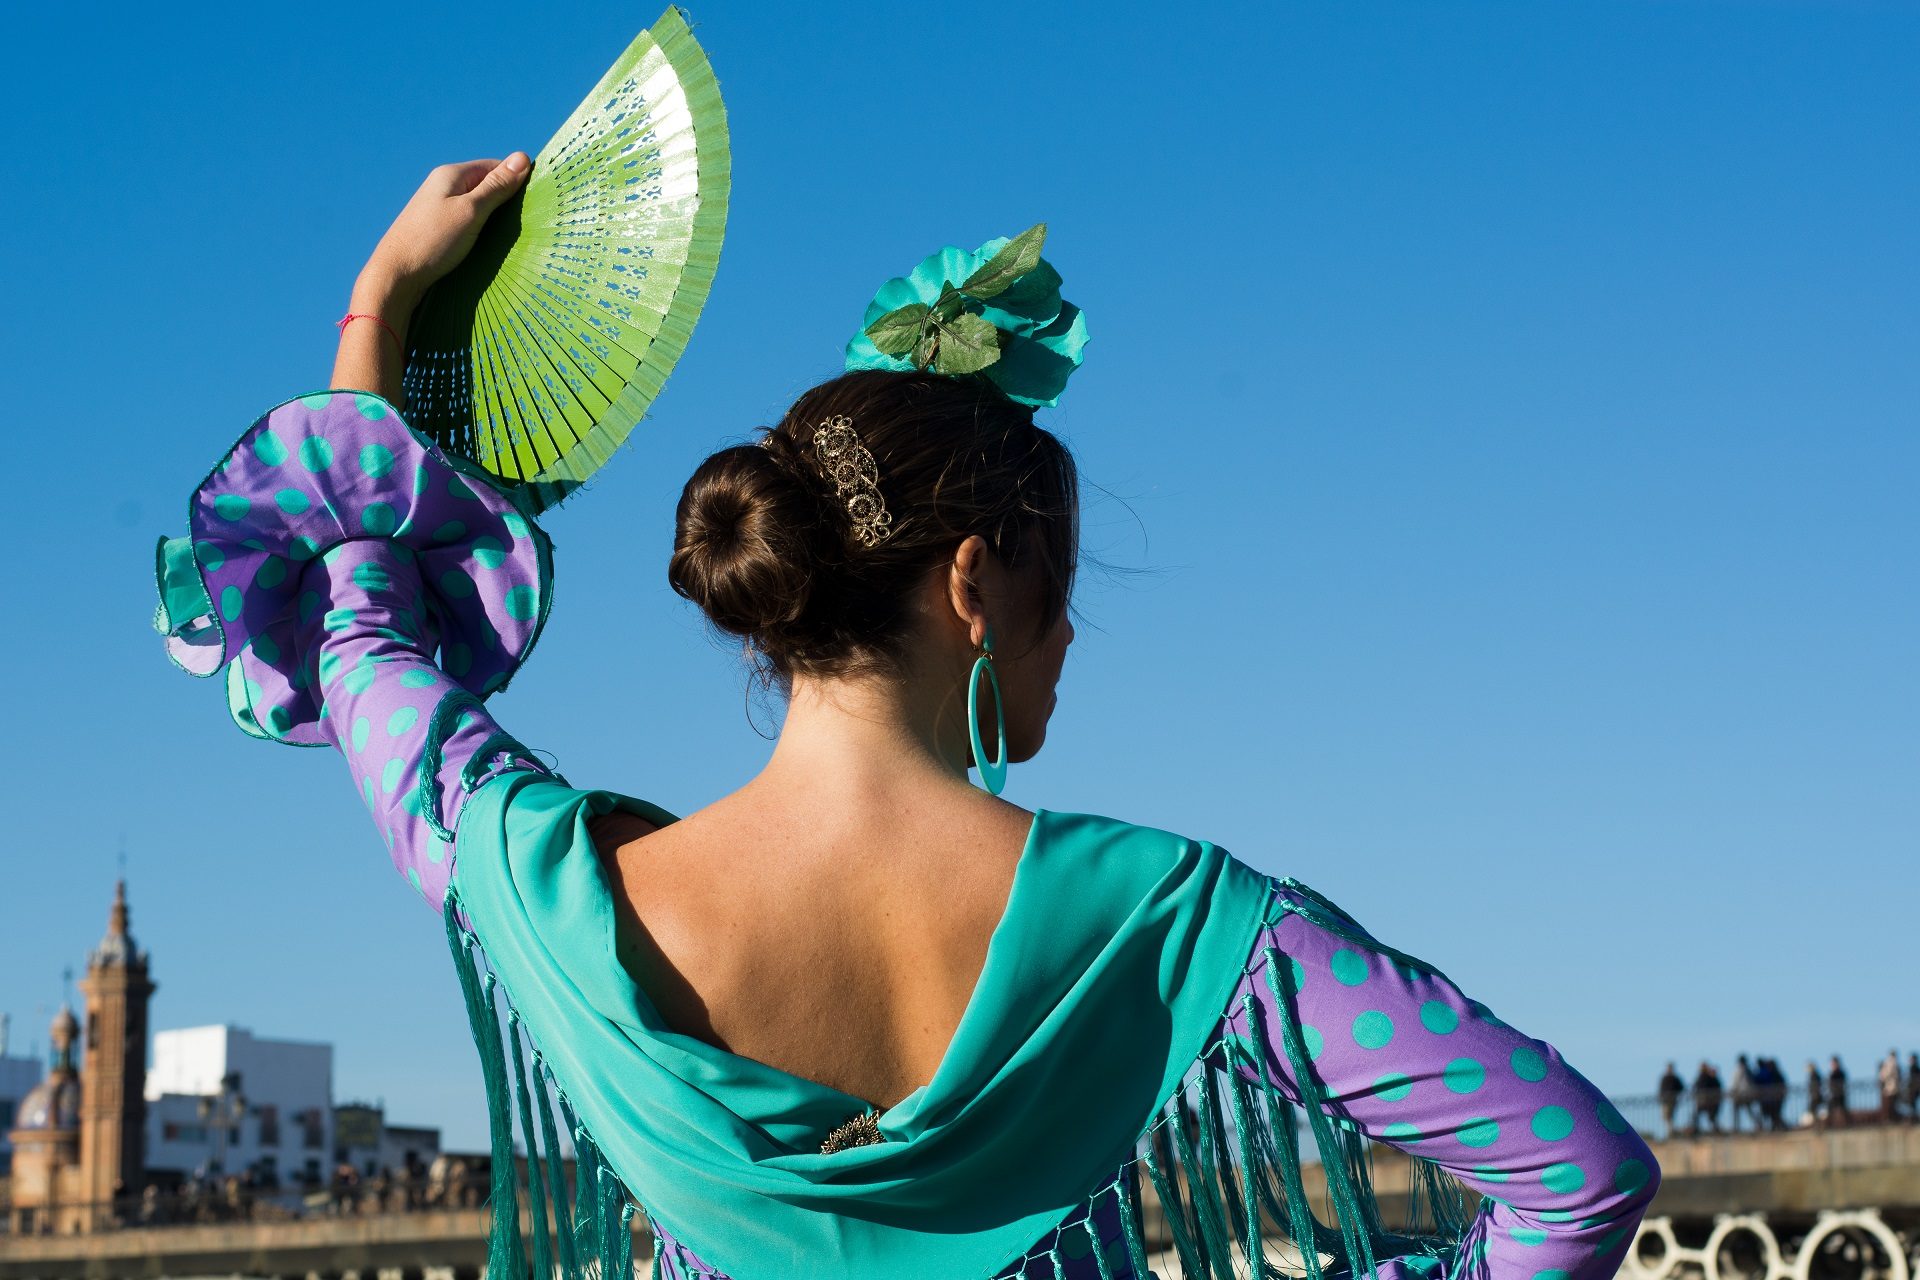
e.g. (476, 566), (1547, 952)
(666, 445), (828, 647)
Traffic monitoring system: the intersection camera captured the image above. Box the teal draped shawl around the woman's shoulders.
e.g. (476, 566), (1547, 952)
(447, 773), (1271, 1280)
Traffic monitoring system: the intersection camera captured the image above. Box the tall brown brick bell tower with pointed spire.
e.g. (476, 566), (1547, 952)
(81, 879), (156, 1230)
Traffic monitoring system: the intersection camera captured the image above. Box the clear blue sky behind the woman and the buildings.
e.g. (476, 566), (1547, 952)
(0, 0), (1920, 1144)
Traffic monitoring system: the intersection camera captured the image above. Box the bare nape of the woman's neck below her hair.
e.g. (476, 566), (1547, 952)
(758, 676), (970, 802)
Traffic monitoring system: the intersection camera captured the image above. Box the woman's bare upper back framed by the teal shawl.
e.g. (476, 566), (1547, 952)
(591, 787), (1033, 1107)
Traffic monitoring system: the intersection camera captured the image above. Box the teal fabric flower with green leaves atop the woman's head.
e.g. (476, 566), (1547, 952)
(847, 223), (1087, 405)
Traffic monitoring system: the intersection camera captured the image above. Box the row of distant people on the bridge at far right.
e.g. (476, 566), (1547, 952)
(1655, 1050), (1920, 1138)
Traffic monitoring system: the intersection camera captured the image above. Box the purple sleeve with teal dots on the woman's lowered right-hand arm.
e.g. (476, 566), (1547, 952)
(1225, 883), (1659, 1280)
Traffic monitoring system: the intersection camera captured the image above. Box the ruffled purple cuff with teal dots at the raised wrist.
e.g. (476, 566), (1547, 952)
(156, 391), (553, 747)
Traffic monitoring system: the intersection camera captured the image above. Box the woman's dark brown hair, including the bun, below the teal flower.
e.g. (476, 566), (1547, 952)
(666, 370), (1079, 677)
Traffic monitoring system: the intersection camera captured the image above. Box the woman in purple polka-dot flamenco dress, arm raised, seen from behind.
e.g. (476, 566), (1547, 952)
(159, 32), (1659, 1280)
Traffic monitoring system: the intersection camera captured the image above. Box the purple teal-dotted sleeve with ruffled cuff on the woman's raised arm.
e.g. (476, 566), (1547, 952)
(156, 391), (553, 908)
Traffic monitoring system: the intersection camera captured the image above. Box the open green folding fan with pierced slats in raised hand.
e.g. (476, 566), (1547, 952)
(403, 8), (732, 512)
